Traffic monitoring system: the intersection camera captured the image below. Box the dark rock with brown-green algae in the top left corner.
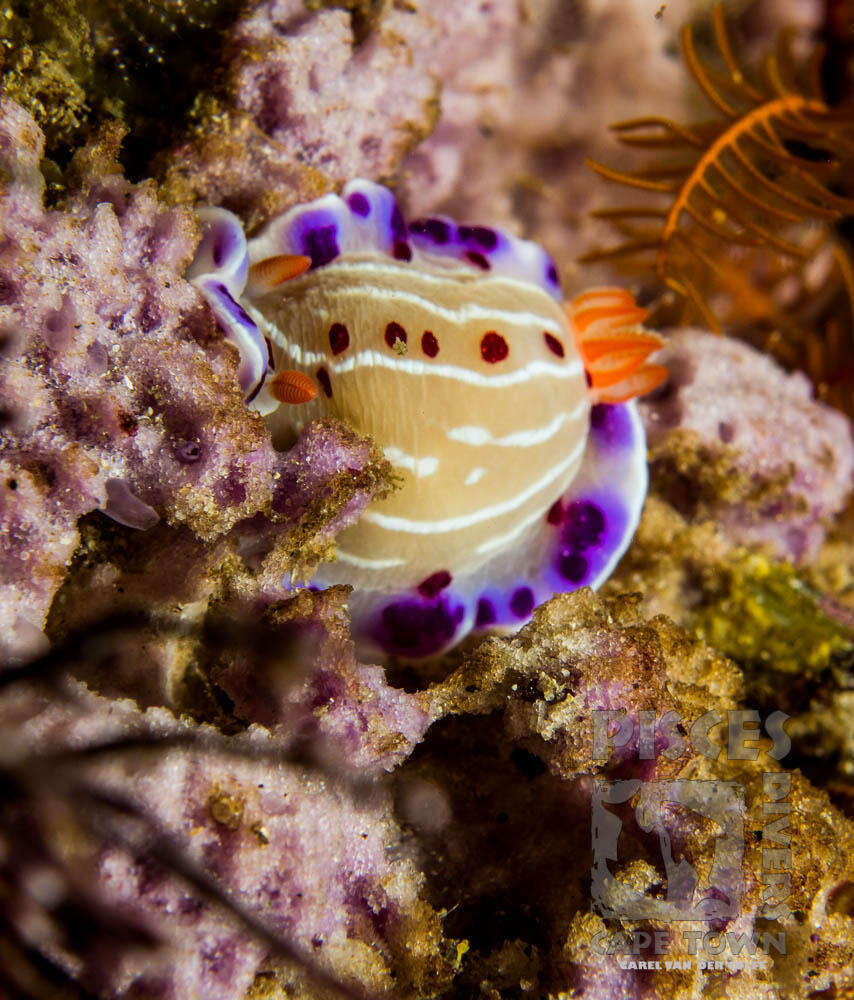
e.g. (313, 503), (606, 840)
(0, 0), (244, 182)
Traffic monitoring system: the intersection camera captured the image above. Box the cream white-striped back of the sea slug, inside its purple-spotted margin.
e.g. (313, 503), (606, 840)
(251, 253), (590, 589)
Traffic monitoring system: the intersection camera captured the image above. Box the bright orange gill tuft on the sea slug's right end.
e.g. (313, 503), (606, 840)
(564, 288), (667, 403)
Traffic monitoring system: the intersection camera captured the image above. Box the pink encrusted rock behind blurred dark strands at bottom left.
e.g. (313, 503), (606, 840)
(0, 684), (454, 1000)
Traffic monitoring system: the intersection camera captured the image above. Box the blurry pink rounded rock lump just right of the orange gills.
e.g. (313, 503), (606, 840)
(640, 330), (854, 562)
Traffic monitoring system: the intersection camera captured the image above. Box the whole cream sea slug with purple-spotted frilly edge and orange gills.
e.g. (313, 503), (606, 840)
(189, 180), (666, 659)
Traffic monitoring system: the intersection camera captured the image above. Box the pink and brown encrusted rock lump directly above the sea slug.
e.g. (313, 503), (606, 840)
(162, 0), (444, 226)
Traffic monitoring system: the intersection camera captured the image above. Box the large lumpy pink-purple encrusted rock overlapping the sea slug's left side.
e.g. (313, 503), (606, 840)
(0, 100), (387, 656)
